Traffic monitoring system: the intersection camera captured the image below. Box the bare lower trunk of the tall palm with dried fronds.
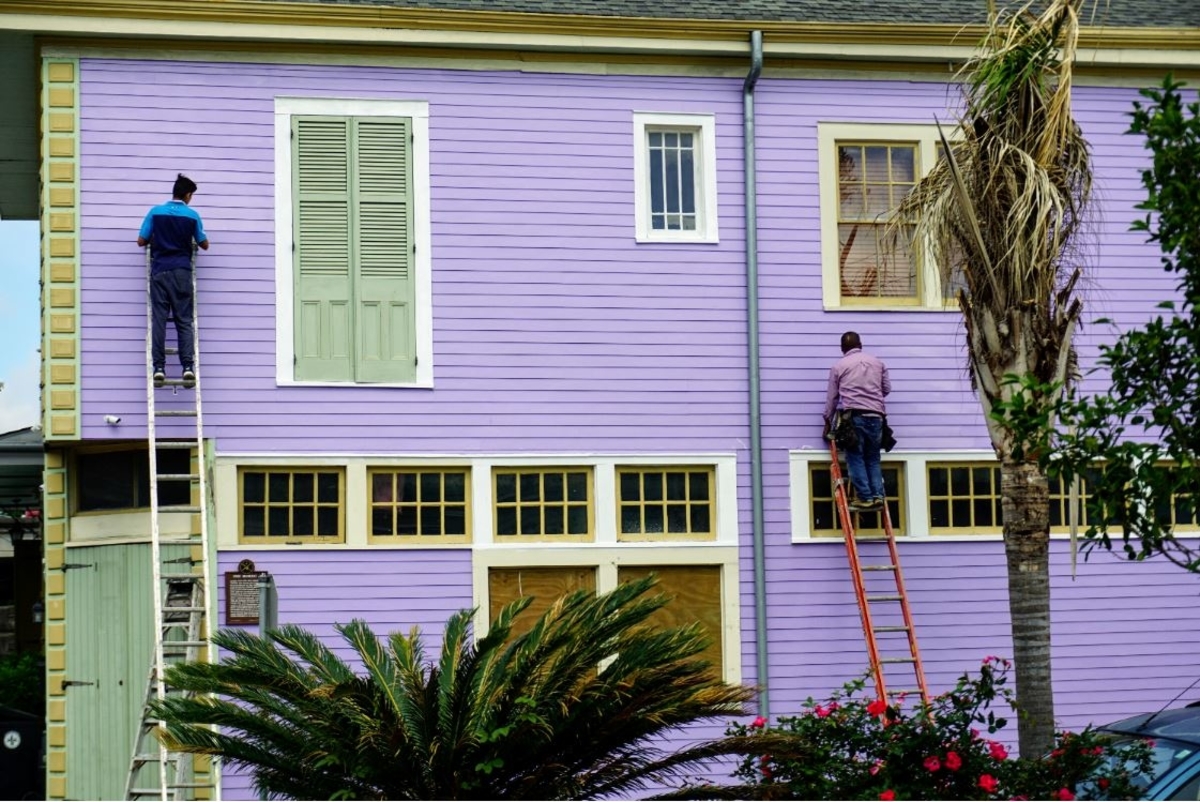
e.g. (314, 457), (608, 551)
(1001, 460), (1054, 758)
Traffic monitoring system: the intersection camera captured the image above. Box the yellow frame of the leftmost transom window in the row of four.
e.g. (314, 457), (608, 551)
(238, 466), (346, 545)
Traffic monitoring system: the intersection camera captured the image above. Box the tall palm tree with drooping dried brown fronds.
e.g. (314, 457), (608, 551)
(893, 0), (1092, 755)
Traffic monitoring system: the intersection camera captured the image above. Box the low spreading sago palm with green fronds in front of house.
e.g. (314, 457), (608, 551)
(155, 577), (782, 800)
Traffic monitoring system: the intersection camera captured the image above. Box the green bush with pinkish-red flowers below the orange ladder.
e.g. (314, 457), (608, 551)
(731, 657), (1151, 800)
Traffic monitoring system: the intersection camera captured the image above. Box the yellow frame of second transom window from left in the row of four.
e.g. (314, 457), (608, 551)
(367, 466), (472, 546)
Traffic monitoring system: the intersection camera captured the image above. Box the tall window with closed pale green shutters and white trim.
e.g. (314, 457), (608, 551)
(276, 98), (432, 384)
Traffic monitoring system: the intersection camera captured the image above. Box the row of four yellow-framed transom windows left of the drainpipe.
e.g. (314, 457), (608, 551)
(238, 466), (715, 545)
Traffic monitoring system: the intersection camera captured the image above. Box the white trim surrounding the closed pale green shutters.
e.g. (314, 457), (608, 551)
(275, 97), (433, 388)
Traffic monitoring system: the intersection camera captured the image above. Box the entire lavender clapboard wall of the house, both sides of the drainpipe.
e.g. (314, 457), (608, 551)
(70, 59), (1200, 797)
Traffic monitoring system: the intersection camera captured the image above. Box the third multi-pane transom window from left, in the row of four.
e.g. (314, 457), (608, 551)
(492, 467), (593, 540)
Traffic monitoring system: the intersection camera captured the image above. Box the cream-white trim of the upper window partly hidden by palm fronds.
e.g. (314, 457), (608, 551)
(817, 122), (958, 312)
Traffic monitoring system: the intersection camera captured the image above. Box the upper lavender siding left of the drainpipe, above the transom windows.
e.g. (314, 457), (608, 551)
(80, 60), (746, 453)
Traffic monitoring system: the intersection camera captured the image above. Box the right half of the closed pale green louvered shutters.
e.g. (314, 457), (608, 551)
(354, 118), (416, 382)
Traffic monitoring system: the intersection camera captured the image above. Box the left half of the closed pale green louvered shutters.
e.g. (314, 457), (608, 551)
(292, 116), (355, 382)
